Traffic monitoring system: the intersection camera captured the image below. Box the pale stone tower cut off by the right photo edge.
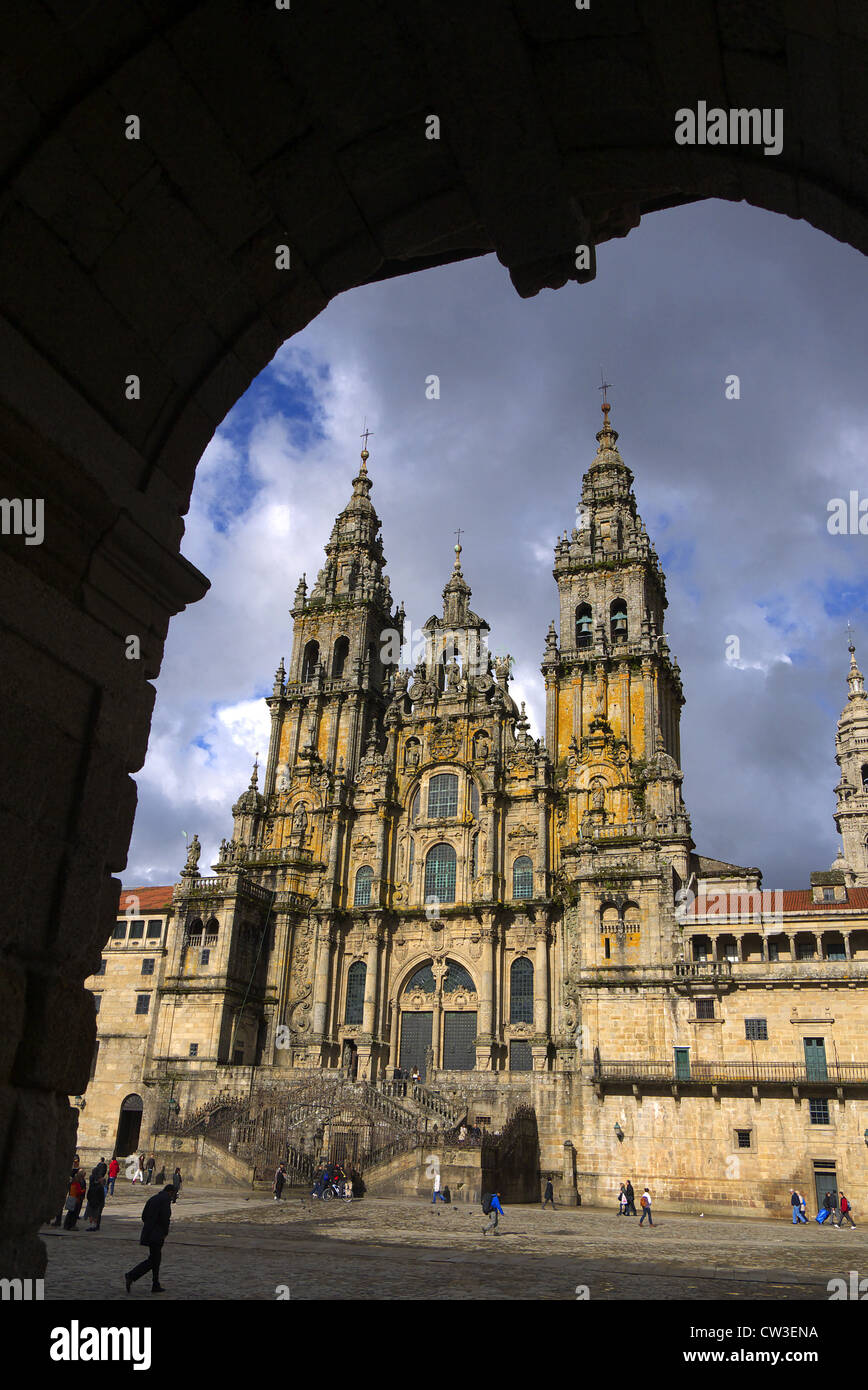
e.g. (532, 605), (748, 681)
(833, 641), (868, 885)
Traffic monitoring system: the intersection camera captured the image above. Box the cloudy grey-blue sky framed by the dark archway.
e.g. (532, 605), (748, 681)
(124, 202), (868, 888)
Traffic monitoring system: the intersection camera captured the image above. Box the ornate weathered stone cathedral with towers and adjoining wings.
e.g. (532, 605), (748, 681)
(79, 404), (868, 1209)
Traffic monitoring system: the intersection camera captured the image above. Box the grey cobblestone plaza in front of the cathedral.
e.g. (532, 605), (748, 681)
(42, 1186), (868, 1307)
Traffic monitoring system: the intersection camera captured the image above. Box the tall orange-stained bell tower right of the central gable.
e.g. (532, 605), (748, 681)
(543, 400), (691, 878)
